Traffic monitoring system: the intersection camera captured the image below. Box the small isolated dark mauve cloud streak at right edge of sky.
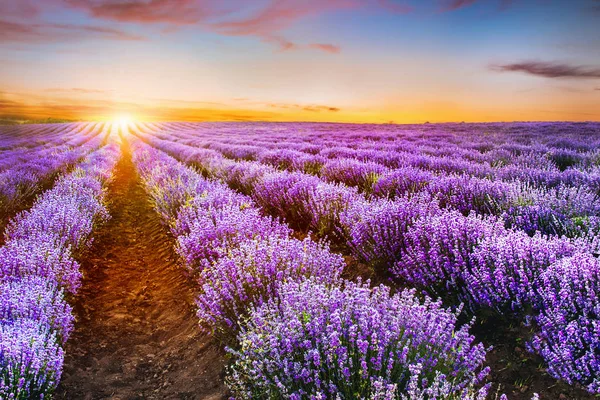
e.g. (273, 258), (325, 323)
(490, 61), (600, 79)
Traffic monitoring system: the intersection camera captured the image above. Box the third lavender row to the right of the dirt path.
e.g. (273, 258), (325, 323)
(138, 124), (600, 241)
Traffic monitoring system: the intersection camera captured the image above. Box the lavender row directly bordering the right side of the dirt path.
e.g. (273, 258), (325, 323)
(134, 143), (488, 399)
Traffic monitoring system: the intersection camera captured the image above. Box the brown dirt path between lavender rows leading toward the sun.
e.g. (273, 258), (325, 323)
(56, 145), (225, 400)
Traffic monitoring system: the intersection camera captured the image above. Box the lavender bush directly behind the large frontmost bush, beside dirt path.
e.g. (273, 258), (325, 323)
(197, 236), (345, 343)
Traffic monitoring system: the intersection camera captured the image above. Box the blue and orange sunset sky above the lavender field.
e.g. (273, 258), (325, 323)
(0, 0), (600, 123)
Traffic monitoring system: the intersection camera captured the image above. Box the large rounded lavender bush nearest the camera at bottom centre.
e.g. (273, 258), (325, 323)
(227, 280), (488, 399)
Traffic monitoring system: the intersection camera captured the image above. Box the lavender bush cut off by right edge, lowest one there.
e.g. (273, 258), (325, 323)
(531, 254), (600, 393)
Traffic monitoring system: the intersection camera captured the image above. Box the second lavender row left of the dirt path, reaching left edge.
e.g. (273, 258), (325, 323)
(0, 122), (108, 222)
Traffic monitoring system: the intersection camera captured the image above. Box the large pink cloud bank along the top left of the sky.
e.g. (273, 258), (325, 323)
(5, 0), (413, 53)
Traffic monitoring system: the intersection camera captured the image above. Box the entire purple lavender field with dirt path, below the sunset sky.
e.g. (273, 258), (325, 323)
(0, 122), (600, 400)
